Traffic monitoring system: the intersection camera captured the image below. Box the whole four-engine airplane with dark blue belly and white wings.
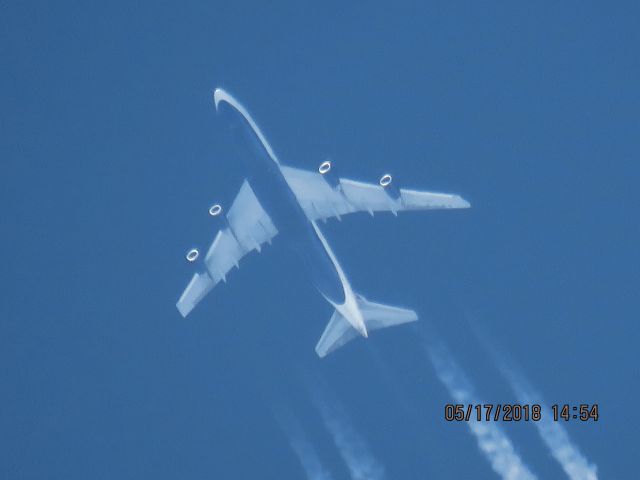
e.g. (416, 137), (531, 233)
(176, 88), (470, 358)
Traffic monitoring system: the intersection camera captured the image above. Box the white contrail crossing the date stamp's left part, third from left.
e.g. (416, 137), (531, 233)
(427, 344), (537, 480)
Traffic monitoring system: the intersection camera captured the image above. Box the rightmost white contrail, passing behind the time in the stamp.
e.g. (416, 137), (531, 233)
(494, 364), (598, 480)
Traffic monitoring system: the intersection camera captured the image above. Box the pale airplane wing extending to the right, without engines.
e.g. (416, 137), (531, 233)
(282, 166), (470, 220)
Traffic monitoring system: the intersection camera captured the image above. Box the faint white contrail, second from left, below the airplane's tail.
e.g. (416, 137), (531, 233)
(313, 390), (385, 480)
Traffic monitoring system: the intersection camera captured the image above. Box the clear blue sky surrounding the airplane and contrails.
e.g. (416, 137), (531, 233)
(0, 1), (640, 479)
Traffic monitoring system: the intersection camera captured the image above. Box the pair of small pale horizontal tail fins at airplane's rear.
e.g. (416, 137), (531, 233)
(316, 295), (418, 358)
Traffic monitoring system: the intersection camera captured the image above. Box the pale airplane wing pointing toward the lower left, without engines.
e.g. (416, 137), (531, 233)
(176, 180), (278, 317)
